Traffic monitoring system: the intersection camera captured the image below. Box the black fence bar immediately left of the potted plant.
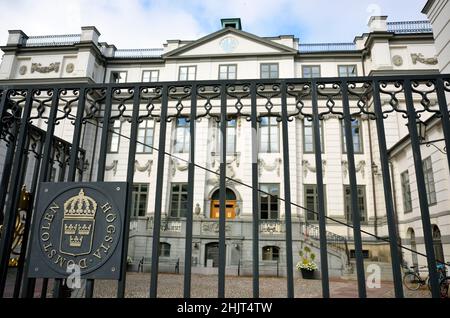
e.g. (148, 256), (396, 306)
(280, 81), (294, 298)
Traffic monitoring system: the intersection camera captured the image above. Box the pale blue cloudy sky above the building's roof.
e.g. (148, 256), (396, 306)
(0, 0), (426, 49)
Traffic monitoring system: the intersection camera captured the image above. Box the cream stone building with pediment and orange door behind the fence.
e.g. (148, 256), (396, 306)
(0, 14), (450, 276)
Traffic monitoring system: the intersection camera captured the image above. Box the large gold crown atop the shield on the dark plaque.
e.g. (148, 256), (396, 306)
(64, 189), (97, 219)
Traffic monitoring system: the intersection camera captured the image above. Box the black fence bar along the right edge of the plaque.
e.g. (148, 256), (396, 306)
(117, 86), (141, 298)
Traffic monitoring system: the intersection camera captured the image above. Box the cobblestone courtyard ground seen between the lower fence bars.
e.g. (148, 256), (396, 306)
(5, 272), (430, 298)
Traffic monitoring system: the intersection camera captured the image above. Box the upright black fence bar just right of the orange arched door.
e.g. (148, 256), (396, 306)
(250, 82), (259, 298)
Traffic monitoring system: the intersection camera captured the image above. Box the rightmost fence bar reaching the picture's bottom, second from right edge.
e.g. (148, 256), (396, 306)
(404, 79), (440, 298)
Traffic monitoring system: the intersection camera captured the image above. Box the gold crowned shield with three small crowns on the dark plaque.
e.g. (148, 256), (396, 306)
(60, 189), (97, 256)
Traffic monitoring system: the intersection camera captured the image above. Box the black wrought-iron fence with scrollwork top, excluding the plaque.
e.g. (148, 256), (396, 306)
(0, 75), (450, 297)
